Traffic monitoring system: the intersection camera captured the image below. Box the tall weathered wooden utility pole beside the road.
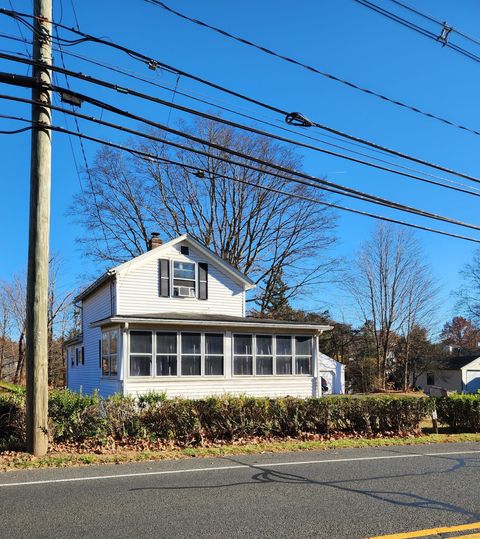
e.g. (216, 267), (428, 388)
(26, 0), (52, 456)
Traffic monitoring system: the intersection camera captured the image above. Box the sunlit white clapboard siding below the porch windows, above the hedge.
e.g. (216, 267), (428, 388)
(125, 376), (315, 398)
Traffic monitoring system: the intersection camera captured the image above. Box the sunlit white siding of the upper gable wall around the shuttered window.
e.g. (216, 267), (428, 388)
(117, 243), (244, 316)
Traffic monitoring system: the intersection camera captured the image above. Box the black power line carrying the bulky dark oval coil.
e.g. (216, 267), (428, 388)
(0, 8), (478, 184)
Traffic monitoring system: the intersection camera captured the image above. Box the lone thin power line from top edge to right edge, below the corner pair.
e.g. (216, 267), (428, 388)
(144, 0), (480, 139)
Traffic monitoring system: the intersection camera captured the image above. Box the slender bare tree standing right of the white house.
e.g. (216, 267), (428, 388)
(348, 224), (438, 388)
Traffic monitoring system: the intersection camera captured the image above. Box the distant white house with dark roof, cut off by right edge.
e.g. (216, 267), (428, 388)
(416, 354), (480, 393)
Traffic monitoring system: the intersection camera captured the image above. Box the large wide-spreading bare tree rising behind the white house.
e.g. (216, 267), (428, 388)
(72, 120), (335, 310)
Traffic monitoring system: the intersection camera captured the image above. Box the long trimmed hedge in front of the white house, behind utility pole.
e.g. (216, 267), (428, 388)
(0, 390), (431, 451)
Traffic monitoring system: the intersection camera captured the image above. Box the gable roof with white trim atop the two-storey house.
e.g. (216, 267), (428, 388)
(75, 234), (256, 301)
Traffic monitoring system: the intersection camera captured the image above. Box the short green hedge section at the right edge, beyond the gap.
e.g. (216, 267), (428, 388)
(436, 393), (480, 432)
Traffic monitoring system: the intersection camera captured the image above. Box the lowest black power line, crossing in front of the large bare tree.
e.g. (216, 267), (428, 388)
(0, 115), (480, 247)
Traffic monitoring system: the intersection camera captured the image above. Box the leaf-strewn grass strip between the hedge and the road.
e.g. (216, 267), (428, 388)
(0, 433), (480, 471)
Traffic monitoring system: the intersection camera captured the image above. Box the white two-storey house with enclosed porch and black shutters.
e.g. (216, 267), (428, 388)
(67, 234), (332, 397)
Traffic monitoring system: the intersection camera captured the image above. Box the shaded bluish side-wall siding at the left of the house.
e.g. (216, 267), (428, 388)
(67, 283), (121, 396)
